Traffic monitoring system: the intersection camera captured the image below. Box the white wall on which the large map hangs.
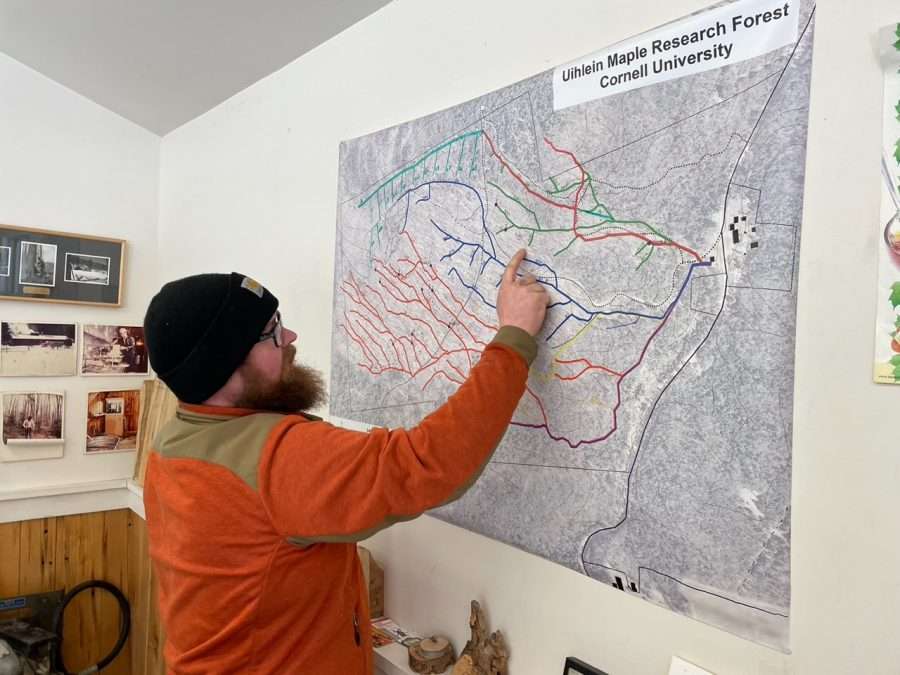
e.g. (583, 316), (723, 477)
(160, 0), (900, 675)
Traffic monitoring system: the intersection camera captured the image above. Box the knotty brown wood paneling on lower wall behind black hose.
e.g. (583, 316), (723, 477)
(0, 509), (165, 675)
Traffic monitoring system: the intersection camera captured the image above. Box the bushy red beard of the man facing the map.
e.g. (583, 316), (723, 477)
(236, 345), (326, 413)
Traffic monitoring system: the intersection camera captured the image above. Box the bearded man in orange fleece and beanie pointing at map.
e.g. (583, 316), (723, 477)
(144, 250), (548, 675)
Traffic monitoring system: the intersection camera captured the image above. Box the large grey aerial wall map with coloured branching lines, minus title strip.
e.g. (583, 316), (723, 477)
(331, 2), (814, 649)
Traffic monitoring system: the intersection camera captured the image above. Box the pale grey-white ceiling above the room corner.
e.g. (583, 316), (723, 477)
(0, 0), (389, 136)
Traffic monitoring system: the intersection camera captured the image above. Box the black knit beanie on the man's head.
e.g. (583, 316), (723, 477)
(144, 272), (278, 403)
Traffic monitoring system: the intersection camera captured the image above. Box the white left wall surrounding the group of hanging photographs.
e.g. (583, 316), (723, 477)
(0, 54), (161, 492)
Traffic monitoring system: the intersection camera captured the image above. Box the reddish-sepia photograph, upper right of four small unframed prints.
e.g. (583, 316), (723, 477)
(81, 324), (148, 375)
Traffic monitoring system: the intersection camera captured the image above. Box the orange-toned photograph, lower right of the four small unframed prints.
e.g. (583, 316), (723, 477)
(85, 389), (141, 454)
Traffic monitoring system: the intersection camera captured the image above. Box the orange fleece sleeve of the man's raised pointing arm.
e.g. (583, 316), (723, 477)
(258, 336), (536, 541)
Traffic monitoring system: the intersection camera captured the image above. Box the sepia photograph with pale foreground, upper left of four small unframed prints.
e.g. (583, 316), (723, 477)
(0, 321), (78, 377)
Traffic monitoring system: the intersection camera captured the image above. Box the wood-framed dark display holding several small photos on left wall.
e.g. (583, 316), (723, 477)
(0, 225), (125, 307)
